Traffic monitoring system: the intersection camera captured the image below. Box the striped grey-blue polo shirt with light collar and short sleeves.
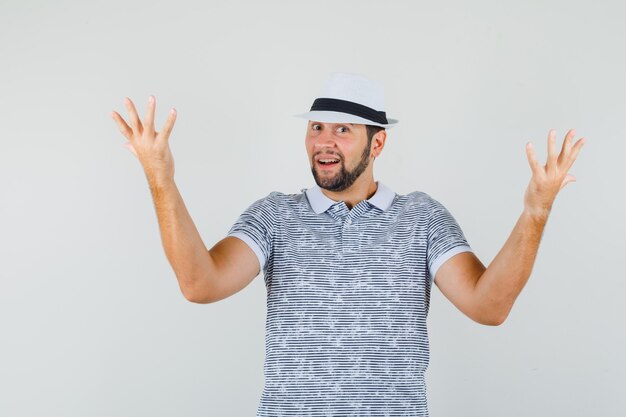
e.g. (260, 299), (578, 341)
(228, 181), (472, 417)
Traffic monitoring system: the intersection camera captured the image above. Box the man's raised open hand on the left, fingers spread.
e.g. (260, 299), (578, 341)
(111, 96), (176, 186)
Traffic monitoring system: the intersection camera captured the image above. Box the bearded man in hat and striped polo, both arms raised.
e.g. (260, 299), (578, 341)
(113, 73), (584, 416)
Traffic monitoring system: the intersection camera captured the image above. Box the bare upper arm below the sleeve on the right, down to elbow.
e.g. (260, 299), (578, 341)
(435, 252), (494, 324)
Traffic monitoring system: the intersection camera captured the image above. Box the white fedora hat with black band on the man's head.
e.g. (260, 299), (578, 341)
(294, 72), (398, 129)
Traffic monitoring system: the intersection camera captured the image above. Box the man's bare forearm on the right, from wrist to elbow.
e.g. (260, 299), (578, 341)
(474, 210), (548, 323)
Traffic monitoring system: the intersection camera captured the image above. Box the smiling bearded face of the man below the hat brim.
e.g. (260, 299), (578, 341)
(305, 121), (370, 191)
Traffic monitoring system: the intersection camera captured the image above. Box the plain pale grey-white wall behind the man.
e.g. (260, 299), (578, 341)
(0, 0), (626, 417)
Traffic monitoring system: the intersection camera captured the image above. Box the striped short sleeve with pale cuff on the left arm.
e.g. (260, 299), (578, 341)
(228, 193), (276, 271)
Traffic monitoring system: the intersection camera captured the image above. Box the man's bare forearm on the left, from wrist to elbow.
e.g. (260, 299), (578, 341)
(148, 179), (212, 298)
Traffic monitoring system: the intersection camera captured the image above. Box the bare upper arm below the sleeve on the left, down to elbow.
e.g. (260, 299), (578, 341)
(189, 236), (260, 304)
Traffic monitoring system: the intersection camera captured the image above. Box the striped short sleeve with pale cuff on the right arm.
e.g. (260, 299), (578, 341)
(426, 197), (473, 284)
